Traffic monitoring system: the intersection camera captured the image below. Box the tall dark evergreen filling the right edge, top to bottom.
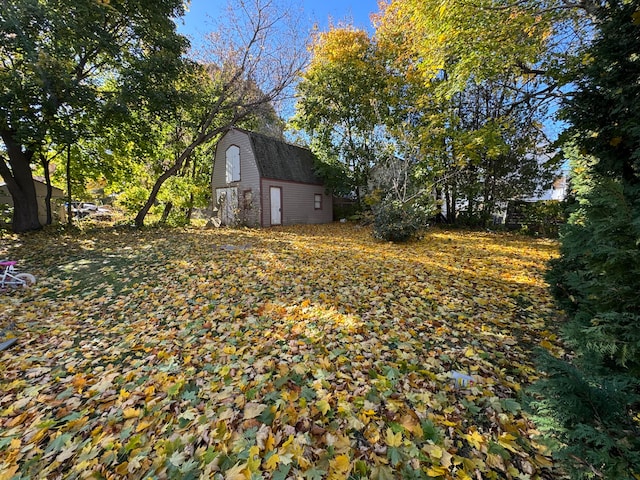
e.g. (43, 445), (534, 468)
(534, 0), (640, 479)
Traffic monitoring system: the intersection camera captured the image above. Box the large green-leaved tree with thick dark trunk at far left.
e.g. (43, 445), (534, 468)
(0, 0), (187, 232)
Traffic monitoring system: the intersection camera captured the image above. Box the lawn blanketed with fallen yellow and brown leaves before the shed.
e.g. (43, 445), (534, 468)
(0, 224), (562, 480)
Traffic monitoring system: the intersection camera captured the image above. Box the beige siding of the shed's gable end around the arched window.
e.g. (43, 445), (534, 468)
(211, 130), (260, 227)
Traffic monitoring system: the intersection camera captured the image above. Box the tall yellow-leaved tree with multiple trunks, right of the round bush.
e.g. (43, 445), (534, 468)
(368, 0), (572, 225)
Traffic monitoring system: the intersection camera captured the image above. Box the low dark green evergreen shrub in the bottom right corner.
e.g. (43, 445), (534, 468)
(528, 354), (640, 479)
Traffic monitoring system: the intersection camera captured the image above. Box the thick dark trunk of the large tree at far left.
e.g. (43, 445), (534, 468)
(0, 130), (42, 233)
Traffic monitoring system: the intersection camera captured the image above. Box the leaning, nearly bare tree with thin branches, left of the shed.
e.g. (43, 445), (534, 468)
(135, 0), (308, 227)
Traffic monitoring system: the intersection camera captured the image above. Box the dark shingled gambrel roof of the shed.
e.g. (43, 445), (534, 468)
(243, 130), (323, 185)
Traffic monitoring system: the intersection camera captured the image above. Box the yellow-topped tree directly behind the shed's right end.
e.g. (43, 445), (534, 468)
(293, 26), (388, 202)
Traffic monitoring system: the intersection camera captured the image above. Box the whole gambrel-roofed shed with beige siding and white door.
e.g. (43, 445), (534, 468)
(211, 128), (333, 227)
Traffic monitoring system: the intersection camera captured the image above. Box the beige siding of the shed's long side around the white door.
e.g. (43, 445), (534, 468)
(261, 179), (333, 227)
